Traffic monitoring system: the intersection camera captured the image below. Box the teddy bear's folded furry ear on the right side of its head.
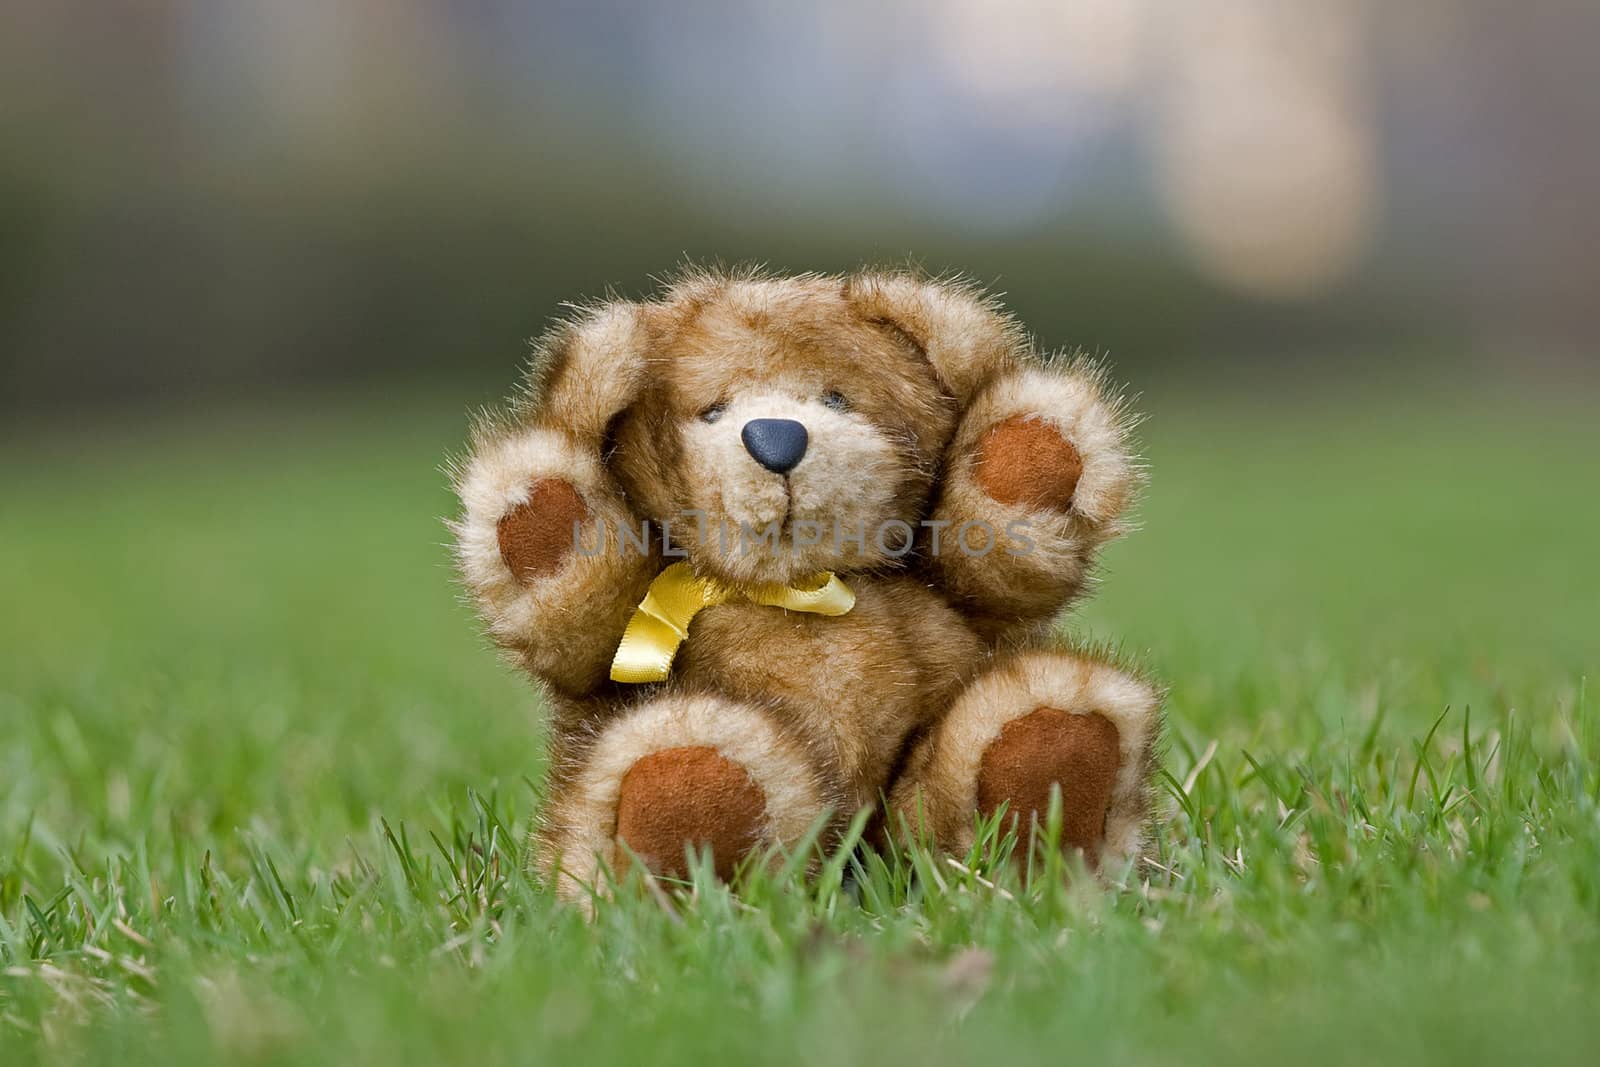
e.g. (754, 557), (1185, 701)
(845, 272), (1030, 406)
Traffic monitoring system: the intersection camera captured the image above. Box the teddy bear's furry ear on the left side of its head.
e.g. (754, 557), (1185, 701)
(514, 301), (650, 448)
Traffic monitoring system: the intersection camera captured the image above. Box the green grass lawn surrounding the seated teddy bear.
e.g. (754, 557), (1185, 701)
(0, 385), (1600, 1064)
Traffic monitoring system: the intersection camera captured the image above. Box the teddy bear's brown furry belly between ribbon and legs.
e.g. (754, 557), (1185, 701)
(674, 577), (987, 803)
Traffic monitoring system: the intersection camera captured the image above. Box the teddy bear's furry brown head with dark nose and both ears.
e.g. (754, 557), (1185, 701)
(505, 272), (1027, 582)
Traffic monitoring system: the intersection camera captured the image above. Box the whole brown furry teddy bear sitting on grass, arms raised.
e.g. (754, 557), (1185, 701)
(454, 270), (1160, 897)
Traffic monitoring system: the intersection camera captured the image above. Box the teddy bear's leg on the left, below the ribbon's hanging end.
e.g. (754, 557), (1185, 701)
(539, 694), (840, 901)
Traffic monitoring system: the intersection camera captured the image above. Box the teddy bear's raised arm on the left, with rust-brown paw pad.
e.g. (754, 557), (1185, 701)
(454, 427), (661, 696)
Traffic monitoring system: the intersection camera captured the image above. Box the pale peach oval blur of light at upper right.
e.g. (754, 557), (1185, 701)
(1152, 0), (1379, 298)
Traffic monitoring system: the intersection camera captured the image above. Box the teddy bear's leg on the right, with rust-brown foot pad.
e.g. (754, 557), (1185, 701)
(888, 649), (1162, 867)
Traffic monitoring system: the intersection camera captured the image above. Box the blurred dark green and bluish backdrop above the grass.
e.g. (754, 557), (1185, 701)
(0, 0), (1600, 415)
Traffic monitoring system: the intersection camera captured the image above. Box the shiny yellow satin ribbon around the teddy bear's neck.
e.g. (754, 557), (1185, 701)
(611, 563), (856, 683)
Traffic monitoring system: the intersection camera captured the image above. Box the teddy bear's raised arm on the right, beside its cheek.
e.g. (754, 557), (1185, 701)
(920, 360), (1138, 632)
